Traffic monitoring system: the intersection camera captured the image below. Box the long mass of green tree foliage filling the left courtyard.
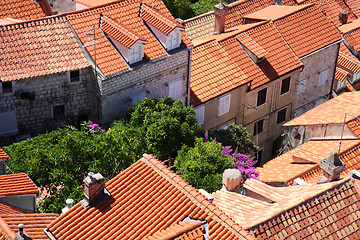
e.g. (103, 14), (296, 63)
(4, 97), (200, 213)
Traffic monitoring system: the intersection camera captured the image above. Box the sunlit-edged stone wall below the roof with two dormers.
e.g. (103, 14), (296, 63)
(99, 49), (191, 124)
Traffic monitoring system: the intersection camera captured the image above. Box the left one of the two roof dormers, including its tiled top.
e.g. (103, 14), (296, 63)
(100, 16), (146, 64)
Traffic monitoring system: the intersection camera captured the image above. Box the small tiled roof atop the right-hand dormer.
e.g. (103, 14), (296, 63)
(140, 4), (184, 35)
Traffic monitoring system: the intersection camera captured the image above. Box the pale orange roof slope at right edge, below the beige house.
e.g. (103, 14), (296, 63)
(284, 92), (360, 127)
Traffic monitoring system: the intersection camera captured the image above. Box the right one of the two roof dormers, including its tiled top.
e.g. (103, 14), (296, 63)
(140, 4), (184, 51)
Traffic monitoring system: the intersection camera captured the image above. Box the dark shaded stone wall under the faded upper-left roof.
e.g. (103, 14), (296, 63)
(0, 68), (97, 142)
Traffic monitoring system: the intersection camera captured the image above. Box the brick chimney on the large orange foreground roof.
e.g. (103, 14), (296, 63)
(84, 172), (105, 204)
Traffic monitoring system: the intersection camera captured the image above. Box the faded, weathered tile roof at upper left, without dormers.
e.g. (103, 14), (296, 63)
(0, 16), (89, 81)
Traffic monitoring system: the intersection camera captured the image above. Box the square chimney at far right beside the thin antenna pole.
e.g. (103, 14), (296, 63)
(319, 153), (345, 183)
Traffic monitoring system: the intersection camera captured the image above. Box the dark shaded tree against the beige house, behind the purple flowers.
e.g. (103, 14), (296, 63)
(209, 123), (259, 154)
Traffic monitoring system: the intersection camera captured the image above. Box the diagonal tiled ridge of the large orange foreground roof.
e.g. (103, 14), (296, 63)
(140, 153), (255, 239)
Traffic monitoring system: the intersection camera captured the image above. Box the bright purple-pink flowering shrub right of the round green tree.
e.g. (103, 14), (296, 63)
(222, 146), (259, 184)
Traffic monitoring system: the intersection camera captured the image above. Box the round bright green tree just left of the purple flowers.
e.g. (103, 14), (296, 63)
(175, 138), (233, 193)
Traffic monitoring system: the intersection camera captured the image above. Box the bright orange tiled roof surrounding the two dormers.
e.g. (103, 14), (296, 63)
(66, 0), (191, 76)
